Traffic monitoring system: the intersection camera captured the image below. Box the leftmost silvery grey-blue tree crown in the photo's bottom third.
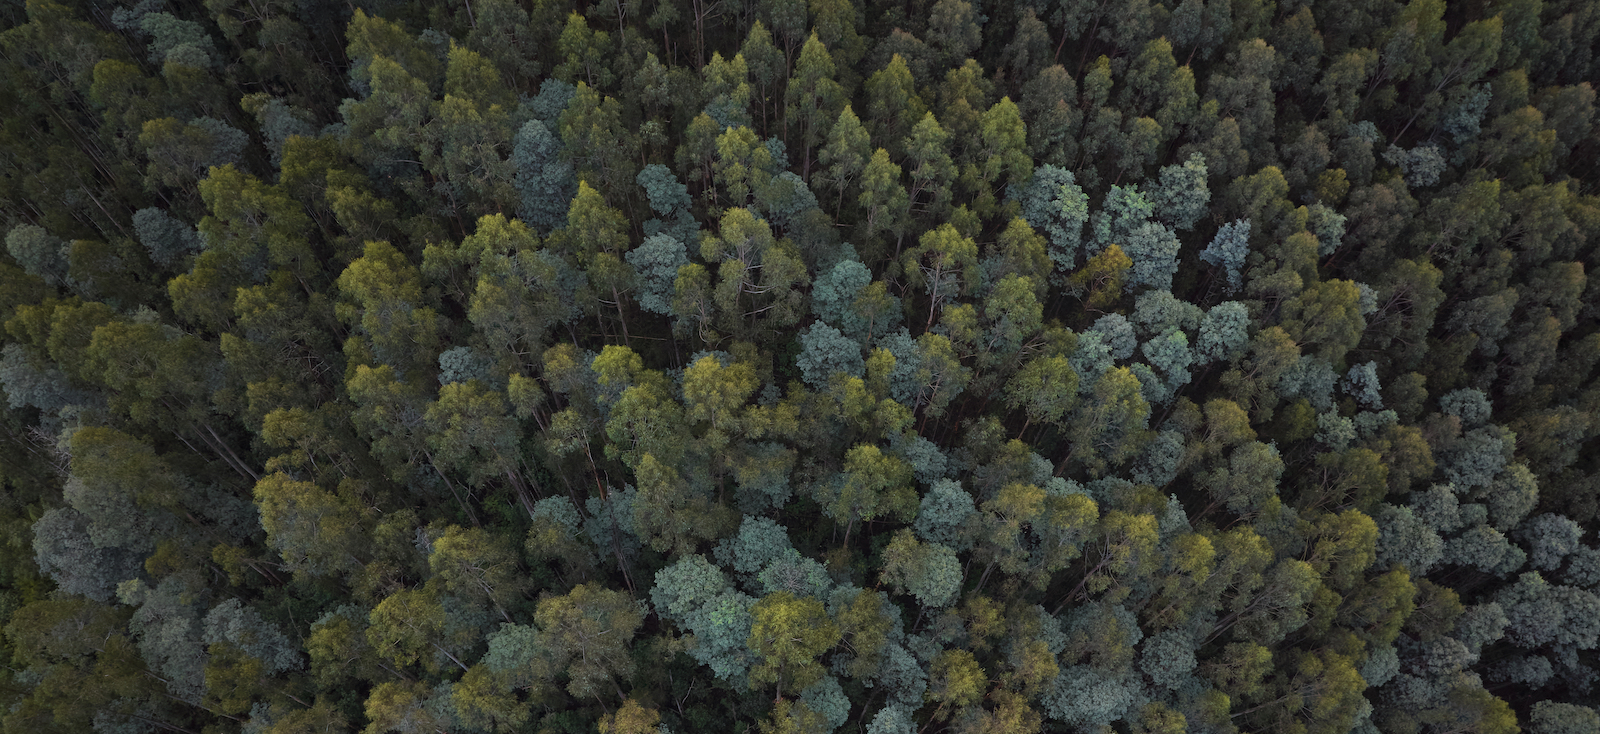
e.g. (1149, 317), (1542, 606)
(34, 507), (144, 603)
